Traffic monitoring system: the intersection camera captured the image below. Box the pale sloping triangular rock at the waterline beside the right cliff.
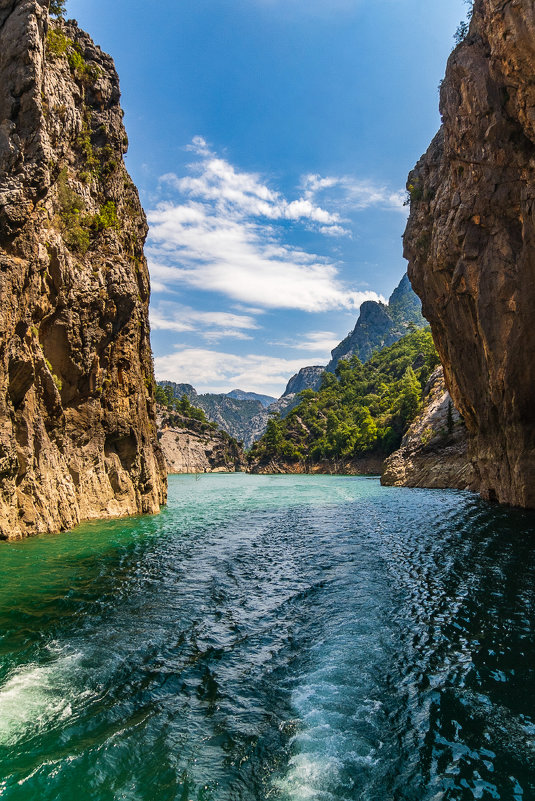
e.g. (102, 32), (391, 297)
(381, 367), (477, 489)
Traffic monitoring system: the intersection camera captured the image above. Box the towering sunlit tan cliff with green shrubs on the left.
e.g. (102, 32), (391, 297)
(0, 0), (166, 538)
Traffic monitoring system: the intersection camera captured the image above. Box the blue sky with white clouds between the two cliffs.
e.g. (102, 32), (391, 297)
(67, 0), (466, 397)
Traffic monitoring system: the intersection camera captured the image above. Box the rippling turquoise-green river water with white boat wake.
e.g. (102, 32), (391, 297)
(0, 475), (535, 801)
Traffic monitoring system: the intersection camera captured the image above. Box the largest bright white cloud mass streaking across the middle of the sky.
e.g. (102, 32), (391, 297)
(147, 137), (397, 312)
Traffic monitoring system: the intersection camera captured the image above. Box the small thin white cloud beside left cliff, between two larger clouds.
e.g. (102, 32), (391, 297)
(150, 302), (258, 342)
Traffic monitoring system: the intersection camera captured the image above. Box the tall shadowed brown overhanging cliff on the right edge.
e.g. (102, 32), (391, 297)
(405, 0), (535, 507)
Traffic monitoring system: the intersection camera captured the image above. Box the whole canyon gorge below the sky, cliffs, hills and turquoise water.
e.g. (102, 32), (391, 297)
(0, 0), (535, 801)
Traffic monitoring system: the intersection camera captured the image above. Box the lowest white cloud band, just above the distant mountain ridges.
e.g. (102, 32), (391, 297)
(154, 348), (328, 397)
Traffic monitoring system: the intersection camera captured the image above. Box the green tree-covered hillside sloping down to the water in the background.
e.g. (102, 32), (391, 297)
(250, 328), (438, 465)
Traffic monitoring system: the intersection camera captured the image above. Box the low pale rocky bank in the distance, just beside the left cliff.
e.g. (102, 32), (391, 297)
(158, 410), (246, 473)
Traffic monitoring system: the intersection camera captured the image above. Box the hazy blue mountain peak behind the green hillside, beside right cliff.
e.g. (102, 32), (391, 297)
(325, 268), (426, 373)
